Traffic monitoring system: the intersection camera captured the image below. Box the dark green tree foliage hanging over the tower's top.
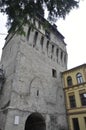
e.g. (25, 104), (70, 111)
(0, 0), (79, 32)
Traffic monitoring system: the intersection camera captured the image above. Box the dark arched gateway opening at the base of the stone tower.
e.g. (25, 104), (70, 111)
(25, 112), (46, 130)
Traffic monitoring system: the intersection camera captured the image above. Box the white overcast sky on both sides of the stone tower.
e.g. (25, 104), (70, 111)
(0, 0), (86, 69)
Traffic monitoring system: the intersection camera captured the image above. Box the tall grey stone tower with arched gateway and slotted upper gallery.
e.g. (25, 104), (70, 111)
(0, 16), (67, 130)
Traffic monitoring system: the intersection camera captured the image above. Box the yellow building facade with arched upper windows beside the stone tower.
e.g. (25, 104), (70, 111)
(62, 64), (86, 130)
